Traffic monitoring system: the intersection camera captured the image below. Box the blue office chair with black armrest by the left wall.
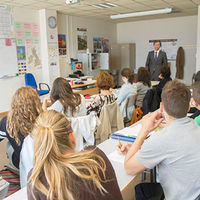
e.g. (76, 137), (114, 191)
(25, 73), (50, 96)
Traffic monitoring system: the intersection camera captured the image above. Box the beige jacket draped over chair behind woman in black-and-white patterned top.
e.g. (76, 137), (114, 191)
(96, 102), (124, 144)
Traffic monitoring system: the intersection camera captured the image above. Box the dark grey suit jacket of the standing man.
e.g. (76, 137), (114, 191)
(146, 50), (167, 81)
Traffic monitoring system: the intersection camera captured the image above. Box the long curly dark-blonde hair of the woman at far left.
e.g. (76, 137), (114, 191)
(6, 87), (42, 145)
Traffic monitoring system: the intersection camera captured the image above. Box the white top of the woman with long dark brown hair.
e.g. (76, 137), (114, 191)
(47, 95), (87, 117)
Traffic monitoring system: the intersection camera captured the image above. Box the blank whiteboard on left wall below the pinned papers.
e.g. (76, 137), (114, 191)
(0, 39), (18, 78)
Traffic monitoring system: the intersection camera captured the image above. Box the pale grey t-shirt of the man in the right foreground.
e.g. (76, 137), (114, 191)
(135, 117), (200, 200)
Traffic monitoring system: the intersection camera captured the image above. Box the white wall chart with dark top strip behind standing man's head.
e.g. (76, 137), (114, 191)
(149, 39), (178, 61)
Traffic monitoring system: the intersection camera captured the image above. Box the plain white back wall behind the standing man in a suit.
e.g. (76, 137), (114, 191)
(117, 16), (197, 83)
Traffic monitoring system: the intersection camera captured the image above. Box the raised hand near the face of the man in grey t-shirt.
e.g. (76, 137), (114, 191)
(142, 112), (163, 135)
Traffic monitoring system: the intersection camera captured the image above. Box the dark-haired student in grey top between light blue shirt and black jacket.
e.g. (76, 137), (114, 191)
(136, 67), (151, 107)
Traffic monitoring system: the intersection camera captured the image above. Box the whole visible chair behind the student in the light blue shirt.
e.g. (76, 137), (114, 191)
(122, 94), (137, 125)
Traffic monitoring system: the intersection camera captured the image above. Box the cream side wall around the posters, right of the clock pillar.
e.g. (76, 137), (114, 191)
(58, 14), (117, 77)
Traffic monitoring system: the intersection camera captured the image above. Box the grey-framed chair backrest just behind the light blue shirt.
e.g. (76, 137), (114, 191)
(124, 94), (137, 119)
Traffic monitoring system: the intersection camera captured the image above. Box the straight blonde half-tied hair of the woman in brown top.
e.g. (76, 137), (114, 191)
(29, 110), (106, 200)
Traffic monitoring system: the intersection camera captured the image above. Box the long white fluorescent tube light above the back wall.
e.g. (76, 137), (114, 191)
(110, 8), (172, 19)
